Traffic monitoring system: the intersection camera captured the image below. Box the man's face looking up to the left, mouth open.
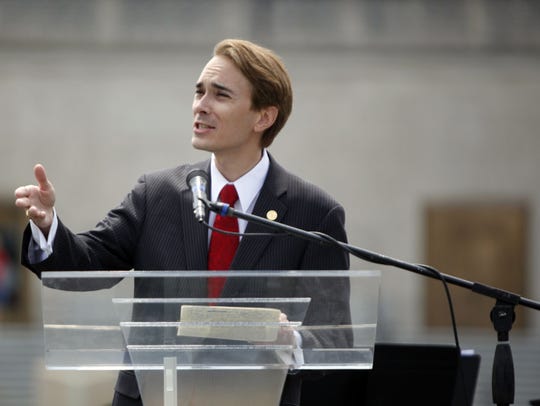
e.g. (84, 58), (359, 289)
(191, 56), (261, 158)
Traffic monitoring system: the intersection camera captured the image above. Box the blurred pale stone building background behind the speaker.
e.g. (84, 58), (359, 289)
(0, 0), (540, 405)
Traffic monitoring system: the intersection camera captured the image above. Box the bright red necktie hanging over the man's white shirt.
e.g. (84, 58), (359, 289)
(208, 184), (239, 297)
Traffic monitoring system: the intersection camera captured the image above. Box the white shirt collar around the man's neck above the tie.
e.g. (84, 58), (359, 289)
(210, 149), (270, 211)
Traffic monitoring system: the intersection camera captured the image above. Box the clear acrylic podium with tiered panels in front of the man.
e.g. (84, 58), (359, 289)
(42, 271), (380, 406)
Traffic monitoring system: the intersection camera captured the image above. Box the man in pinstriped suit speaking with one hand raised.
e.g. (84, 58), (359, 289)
(15, 40), (350, 405)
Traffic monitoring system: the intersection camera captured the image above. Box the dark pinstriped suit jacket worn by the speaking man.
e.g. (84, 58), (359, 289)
(22, 157), (350, 404)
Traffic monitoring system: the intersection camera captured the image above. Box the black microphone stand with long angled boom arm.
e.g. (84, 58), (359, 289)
(204, 199), (540, 406)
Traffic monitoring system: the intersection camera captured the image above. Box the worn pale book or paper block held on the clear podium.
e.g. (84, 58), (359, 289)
(177, 305), (281, 342)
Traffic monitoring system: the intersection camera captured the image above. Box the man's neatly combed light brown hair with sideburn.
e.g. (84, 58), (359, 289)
(214, 39), (292, 148)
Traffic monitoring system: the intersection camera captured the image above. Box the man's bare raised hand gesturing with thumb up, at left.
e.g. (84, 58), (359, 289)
(15, 164), (56, 235)
